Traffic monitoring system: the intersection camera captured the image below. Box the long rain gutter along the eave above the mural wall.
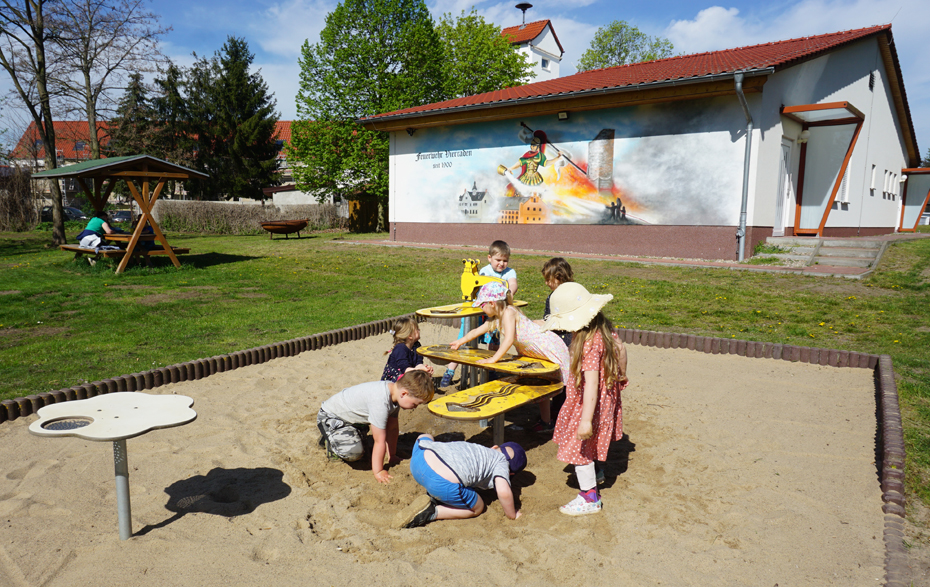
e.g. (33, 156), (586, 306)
(355, 67), (775, 130)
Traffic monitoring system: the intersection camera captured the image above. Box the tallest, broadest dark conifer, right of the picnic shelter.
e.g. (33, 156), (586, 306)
(185, 37), (280, 200)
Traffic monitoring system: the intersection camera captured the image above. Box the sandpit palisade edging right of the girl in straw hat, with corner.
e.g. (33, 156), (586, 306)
(616, 328), (910, 587)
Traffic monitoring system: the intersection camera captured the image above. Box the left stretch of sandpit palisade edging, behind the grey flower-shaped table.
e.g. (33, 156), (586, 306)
(0, 314), (422, 424)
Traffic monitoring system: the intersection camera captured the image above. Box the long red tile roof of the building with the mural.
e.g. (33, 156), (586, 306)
(361, 23), (891, 122)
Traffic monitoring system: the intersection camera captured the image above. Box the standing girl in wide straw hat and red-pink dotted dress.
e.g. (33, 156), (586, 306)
(545, 283), (629, 516)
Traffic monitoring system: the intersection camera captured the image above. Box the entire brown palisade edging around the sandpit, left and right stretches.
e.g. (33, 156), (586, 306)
(0, 322), (910, 587)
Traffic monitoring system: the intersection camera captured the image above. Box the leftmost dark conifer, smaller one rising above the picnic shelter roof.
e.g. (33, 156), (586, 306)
(106, 73), (160, 157)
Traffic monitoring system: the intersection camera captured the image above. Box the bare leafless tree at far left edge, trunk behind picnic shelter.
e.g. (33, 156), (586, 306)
(0, 0), (65, 245)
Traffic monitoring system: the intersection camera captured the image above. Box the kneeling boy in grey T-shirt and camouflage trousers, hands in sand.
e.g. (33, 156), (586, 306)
(316, 370), (434, 483)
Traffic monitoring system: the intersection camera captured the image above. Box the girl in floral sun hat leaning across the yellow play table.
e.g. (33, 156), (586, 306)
(449, 282), (569, 429)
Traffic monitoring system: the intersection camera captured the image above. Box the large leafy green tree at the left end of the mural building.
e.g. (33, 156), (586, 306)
(286, 0), (443, 225)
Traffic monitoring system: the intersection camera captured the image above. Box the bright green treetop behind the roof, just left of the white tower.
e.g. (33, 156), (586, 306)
(436, 8), (536, 99)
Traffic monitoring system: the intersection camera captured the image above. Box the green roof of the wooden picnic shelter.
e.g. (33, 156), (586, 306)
(32, 155), (208, 180)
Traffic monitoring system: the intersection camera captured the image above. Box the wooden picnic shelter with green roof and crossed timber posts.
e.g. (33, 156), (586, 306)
(32, 155), (207, 273)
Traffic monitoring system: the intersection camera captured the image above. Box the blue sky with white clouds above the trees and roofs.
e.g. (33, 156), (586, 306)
(0, 0), (930, 155)
